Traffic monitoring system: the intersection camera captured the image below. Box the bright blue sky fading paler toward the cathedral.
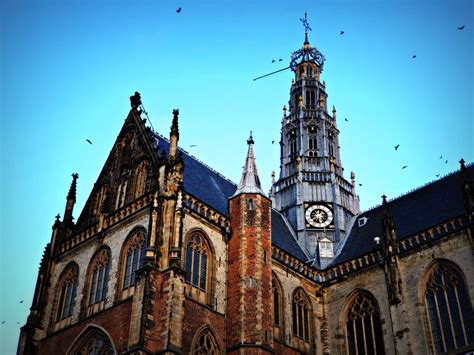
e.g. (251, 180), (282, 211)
(0, 0), (474, 354)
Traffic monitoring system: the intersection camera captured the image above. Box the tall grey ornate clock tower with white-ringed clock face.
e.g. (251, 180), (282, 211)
(271, 14), (359, 266)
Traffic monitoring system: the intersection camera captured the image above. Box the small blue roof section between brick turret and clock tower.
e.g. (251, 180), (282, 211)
(272, 208), (308, 261)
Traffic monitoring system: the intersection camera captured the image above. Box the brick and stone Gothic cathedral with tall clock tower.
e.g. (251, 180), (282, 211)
(18, 17), (474, 355)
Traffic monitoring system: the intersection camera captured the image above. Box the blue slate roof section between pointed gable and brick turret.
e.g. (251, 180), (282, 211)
(154, 133), (237, 216)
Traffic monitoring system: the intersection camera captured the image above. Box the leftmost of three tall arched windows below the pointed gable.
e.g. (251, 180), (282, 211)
(56, 264), (79, 322)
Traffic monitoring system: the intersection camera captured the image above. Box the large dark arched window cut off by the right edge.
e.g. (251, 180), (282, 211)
(425, 262), (474, 354)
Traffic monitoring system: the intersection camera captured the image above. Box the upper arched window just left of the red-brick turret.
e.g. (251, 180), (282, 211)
(185, 234), (209, 291)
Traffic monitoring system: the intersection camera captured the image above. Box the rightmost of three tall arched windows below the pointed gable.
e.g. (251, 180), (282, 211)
(121, 230), (146, 298)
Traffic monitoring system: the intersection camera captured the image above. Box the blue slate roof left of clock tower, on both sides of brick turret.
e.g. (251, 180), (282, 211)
(153, 133), (308, 261)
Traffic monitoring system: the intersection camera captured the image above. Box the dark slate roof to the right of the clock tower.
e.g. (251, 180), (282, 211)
(331, 164), (474, 265)
